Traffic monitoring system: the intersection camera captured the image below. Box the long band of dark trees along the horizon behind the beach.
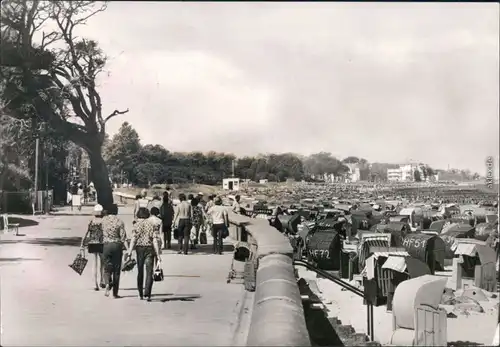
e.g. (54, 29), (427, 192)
(103, 122), (432, 186)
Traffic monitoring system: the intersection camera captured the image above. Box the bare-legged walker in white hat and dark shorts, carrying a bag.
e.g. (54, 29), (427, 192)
(80, 204), (106, 291)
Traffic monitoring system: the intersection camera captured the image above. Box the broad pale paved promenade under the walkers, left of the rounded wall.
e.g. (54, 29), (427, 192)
(0, 208), (244, 346)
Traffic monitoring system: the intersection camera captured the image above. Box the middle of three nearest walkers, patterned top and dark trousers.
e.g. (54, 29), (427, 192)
(101, 204), (128, 298)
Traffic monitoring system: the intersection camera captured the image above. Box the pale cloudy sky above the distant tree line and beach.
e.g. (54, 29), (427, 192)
(76, 2), (499, 174)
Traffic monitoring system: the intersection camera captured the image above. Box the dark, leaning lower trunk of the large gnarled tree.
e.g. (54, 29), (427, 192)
(88, 147), (113, 210)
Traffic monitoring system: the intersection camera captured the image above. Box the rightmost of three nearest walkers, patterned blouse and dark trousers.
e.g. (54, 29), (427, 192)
(128, 207), (161, 301)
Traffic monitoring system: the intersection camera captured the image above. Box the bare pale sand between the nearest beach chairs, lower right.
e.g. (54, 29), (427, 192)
(299, 269), (499, 345)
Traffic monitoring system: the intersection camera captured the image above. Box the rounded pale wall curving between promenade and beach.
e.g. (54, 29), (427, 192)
(229, 213), (311, 346)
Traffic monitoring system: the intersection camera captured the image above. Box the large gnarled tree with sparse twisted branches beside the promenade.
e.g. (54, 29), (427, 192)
(1, 0), (128, 208)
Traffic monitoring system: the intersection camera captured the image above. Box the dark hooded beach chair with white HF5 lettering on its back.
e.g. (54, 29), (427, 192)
(403, 234), (446, 275)
